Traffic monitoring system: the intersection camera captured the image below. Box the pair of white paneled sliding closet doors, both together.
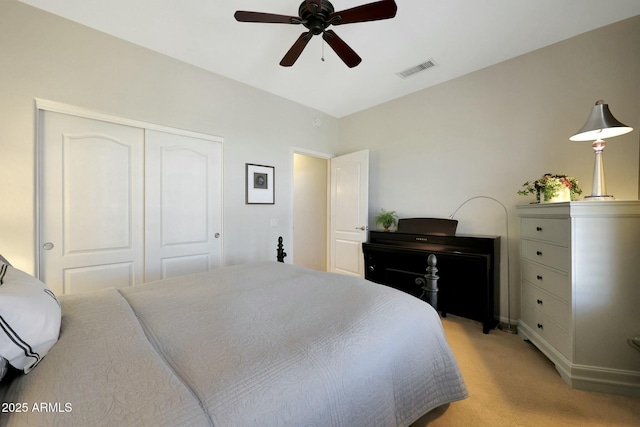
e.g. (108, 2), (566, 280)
(38, 105), (222, 295)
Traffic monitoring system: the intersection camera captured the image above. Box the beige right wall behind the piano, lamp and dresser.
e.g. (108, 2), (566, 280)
(340, 16), (640, 319)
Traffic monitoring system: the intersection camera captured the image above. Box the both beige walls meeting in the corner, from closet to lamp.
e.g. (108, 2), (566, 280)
(0, 0), (640, 317)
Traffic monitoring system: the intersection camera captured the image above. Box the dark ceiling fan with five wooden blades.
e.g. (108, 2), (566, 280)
(234, 0), (398, 68)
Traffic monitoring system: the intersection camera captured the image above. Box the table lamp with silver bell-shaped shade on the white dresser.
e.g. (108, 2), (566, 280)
(569, 100), (633, 201)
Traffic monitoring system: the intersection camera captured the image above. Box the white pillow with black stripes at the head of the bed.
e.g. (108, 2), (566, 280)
(0, 262), (61, 374)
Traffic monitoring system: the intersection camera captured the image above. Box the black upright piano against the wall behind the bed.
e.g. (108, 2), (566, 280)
(362, 218), (500, 334)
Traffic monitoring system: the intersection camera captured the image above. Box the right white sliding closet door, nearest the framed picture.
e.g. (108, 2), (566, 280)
(145, 130), (222, 281)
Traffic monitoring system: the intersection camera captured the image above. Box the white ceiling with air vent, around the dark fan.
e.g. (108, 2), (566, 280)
(20, 0), (640, 118)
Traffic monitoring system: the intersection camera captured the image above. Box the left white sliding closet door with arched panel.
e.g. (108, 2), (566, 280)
(38, 111), (144, 295)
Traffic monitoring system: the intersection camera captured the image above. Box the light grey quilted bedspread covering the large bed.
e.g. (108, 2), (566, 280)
(0, 262), (467, 427)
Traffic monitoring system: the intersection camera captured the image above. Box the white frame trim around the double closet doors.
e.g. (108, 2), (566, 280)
(34, 98), (225, 277)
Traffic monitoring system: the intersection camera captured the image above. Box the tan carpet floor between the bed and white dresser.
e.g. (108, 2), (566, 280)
(411, 315), (640, 427)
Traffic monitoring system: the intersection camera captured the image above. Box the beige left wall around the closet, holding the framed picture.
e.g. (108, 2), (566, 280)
(0, 1), (338, 271)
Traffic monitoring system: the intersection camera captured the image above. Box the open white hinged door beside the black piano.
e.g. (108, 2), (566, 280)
(330, 150), (369, 277)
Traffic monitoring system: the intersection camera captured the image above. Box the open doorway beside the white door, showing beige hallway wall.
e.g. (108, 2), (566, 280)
(292, 152), (329, 271)
